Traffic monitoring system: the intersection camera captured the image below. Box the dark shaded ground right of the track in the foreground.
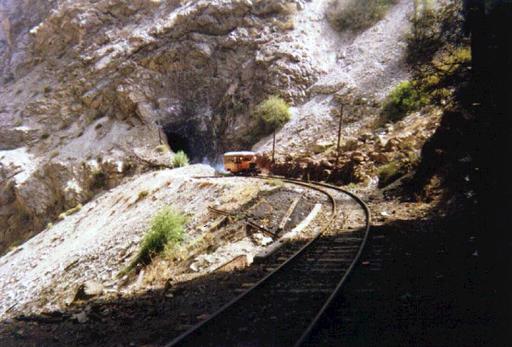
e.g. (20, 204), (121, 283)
(306, 208), (510, 346)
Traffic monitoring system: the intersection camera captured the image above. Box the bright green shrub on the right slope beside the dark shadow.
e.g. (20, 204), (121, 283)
(382, 81), (430, 122)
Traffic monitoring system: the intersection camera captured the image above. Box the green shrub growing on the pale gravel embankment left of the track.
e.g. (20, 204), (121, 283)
(120, 207), (188, 275)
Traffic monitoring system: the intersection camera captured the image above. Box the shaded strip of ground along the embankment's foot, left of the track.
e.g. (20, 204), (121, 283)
(0, 242), (304, 347)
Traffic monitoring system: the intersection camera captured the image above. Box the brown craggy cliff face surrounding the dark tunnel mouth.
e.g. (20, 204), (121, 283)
(0, 0), (328, 250)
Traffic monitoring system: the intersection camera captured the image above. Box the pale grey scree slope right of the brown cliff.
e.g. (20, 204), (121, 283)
(255, 0), (412, 157)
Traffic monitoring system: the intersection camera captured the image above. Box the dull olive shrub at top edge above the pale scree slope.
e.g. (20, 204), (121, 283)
(327, 0), (397, 31)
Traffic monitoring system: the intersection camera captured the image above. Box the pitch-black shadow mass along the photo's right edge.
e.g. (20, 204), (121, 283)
(409, 0), (512, 336)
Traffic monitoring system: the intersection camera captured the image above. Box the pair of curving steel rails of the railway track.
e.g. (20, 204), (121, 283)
(166, 176), (371, 347)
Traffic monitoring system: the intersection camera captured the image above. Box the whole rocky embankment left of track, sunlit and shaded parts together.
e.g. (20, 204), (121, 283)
(0, 165), (364, 346)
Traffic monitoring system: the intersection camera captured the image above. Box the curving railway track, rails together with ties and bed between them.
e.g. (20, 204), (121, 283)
(167, 176), (371, 347)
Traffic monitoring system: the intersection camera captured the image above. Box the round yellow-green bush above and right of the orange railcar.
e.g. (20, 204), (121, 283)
(254, 96), (292, 133)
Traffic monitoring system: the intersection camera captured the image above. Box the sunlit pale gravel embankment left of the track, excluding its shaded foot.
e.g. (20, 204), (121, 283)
(0, 165), (332, 317)
